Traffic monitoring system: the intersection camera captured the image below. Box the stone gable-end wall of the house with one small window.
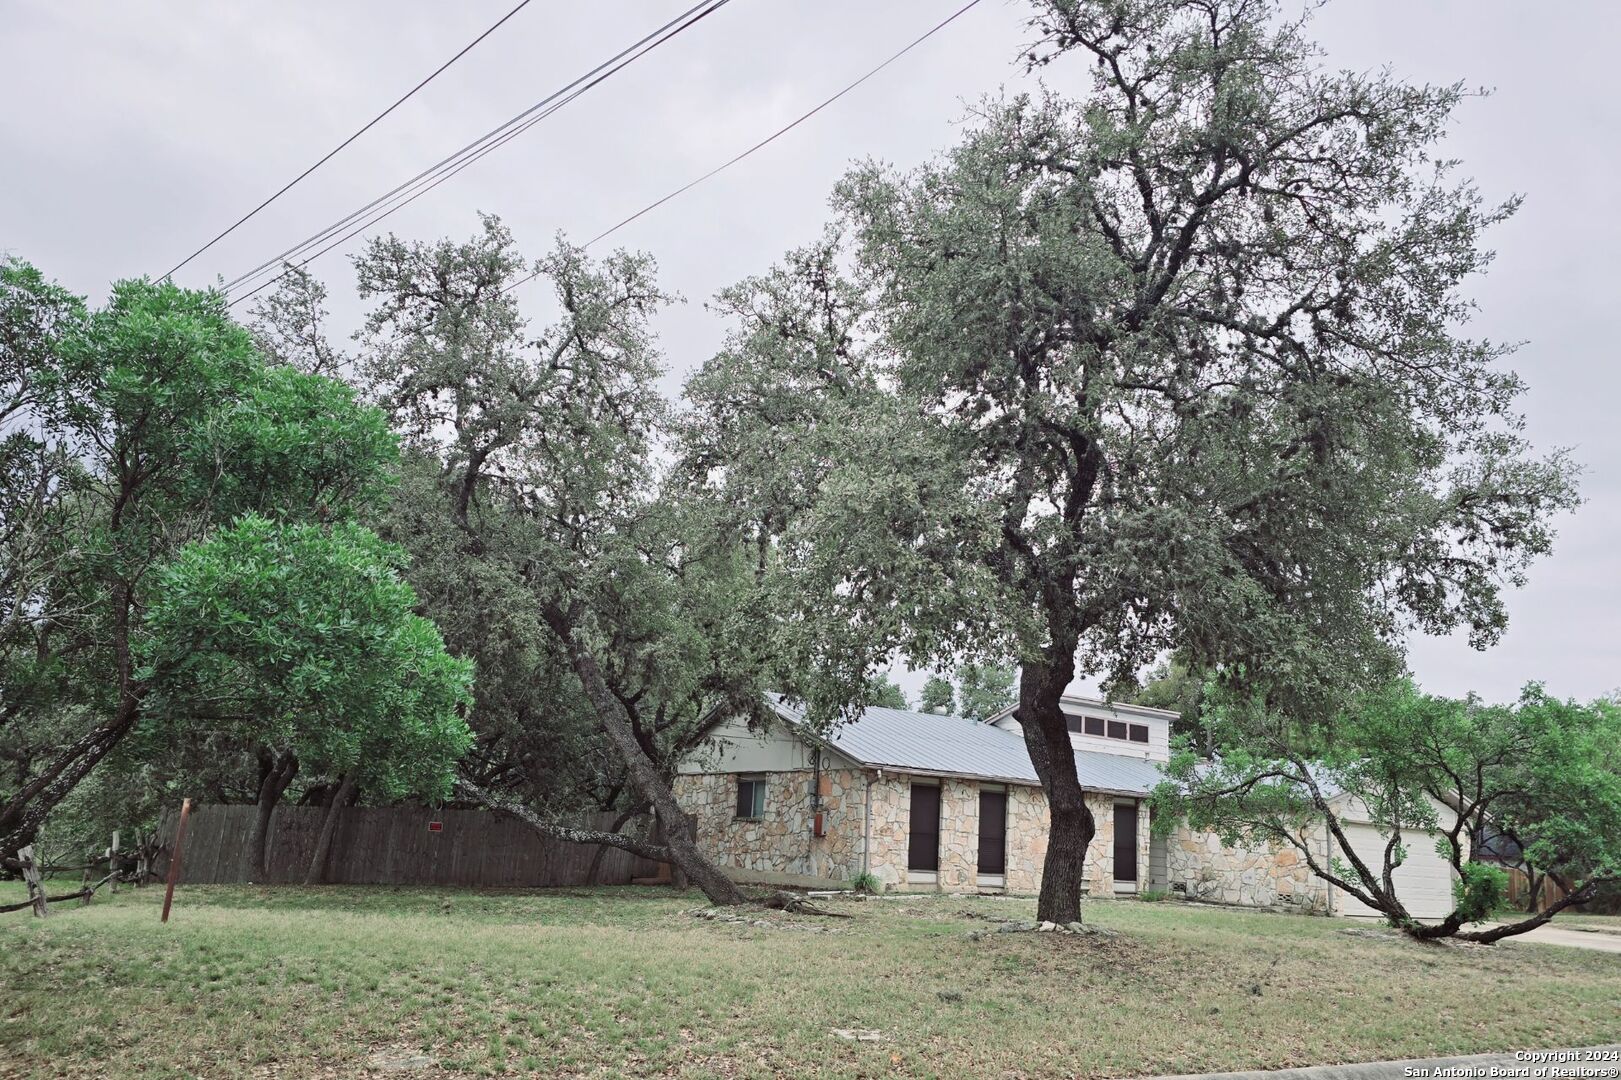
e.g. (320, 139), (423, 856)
(674, 769), (868, 882)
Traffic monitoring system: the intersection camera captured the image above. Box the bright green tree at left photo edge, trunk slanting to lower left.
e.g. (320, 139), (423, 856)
(0, 270), (394, 859)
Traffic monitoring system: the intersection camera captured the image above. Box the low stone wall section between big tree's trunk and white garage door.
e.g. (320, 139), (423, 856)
(1165, 824), (1328, 913)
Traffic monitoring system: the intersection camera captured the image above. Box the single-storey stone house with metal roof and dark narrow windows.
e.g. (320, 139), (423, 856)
(674, 696), (1452, 918)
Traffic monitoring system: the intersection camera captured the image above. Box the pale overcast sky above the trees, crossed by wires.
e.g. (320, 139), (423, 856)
(0, 0), (1621, 699)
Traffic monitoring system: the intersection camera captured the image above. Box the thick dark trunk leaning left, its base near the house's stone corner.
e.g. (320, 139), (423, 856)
(546, 611), (745, 905)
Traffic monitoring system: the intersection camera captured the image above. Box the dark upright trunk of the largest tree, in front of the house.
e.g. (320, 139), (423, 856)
(1018, 634), (1097, 926)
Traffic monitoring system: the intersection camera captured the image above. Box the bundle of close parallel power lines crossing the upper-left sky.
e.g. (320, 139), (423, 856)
(225, 0), (731, 306)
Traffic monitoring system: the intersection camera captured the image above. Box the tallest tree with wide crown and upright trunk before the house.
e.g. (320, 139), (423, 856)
(716, 0), (1574, 923)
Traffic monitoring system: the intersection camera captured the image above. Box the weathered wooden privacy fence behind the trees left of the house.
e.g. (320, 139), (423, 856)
(156, 806), (660, 889)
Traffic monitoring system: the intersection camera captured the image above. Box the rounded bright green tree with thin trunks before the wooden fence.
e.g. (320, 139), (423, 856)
(139, 514), (473, 877)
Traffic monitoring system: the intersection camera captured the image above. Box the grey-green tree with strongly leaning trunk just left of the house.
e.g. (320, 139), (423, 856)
(338, 217), (781, 903)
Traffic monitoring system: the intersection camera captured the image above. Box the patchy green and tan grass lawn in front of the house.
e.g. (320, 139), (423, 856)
(0, 885), (1621, 1080)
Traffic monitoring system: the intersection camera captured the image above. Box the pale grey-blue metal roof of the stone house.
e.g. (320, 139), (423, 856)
(770, 694), (1164, 795)
